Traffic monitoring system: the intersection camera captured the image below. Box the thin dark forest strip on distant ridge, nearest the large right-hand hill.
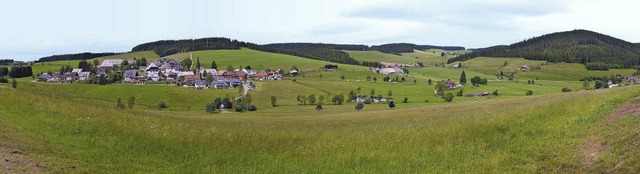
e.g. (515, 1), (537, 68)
(370, 43), (465, 54)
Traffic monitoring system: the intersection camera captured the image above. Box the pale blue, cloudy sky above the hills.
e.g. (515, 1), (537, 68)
(0, 0), (640, 61)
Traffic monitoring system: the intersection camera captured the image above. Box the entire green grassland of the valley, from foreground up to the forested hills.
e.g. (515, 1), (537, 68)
(0, 48), (640, 173)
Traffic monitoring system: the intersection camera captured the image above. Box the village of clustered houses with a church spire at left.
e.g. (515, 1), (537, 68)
(37, 58), (298, 89)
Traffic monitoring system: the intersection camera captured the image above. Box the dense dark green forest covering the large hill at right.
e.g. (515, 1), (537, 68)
(448, 30), (640, 70)
